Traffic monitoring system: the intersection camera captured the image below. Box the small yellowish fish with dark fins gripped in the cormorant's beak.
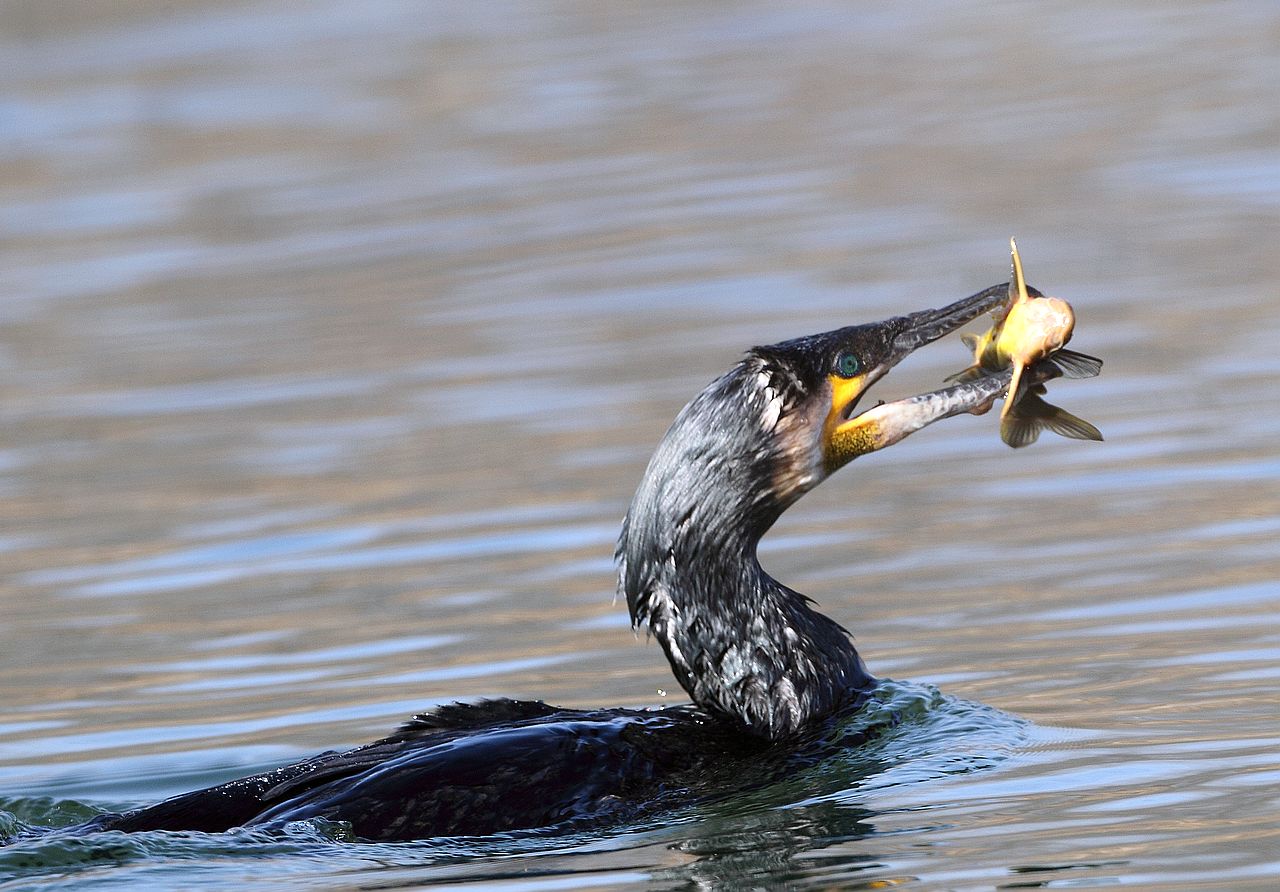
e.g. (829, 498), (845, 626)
(947, 238), (1102, 449)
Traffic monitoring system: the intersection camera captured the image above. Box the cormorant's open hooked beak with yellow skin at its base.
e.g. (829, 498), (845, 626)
(823, 284), (1009, 474)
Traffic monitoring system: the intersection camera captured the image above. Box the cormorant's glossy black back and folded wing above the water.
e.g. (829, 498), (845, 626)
(81, 700), (754, 840)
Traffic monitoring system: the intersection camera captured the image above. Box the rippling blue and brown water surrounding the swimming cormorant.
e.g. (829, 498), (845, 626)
(0, 0), (1280, 889)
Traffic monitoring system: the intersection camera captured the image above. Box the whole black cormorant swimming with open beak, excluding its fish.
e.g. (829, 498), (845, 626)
(64, 284), (1034, 840)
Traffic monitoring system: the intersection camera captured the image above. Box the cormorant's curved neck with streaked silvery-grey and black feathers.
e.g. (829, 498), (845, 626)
(618, 360), (872, 738)
